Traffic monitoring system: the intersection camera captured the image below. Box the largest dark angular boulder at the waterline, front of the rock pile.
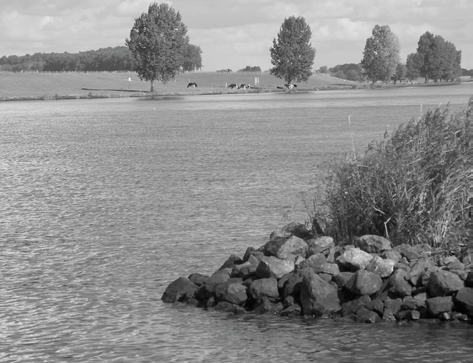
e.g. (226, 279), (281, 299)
(300, 272), (340, 316)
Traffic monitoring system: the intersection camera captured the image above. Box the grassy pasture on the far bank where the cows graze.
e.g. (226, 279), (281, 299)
(0, 72), (357, 100)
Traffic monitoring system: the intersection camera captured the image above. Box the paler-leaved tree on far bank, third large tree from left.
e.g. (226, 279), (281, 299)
(361, 25), (401, 83)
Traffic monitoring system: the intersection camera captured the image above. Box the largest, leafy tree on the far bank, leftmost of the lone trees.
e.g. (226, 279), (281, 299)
(125, 2), (189, 92)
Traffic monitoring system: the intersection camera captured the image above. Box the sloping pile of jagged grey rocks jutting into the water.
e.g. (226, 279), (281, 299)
(162, 223), (473, 323)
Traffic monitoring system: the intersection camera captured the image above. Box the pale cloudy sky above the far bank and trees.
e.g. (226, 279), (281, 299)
(0, 0), (473, 72)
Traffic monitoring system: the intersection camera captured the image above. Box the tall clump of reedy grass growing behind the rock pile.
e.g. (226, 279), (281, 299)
(311, 97), (473, 248)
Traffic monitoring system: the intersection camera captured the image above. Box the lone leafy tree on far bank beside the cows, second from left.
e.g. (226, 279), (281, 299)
(269, 16), (315, 83)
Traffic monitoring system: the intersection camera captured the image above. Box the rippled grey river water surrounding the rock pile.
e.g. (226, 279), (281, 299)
(0, 83), (473, 362)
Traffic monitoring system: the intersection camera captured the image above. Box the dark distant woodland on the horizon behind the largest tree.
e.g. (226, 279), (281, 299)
(0, 44), (202, 72)
